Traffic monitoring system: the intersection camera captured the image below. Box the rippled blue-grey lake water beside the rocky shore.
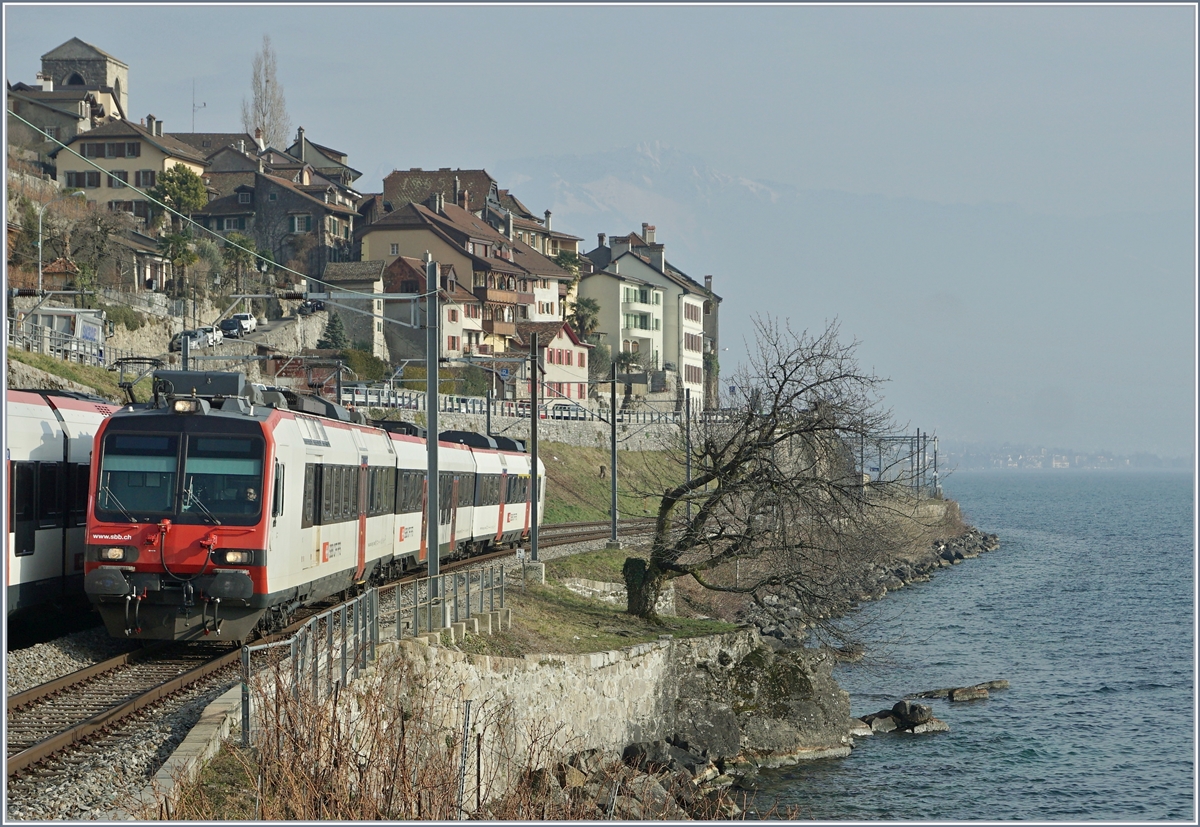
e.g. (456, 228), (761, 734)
(763, 472), (1195, 821)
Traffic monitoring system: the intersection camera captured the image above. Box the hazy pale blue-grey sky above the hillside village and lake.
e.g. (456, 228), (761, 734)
(5, 4), (1196, 455)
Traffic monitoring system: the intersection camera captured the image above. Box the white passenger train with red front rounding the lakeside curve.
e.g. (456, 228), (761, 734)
(84, 370), (545, 642)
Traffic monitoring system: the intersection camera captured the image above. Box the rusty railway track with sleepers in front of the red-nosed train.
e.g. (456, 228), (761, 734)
(5, 645), (239, 775)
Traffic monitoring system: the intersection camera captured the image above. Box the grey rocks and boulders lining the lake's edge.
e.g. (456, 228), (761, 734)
(597, 528), (1008, 819)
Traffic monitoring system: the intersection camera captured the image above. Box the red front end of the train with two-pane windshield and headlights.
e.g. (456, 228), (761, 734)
(84, 410), (272, 640)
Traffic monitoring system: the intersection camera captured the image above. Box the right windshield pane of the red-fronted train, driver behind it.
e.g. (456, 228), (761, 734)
(180, 433), (263, 525)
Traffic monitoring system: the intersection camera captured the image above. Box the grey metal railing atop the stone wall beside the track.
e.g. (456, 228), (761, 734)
(241, 565), (504, 745)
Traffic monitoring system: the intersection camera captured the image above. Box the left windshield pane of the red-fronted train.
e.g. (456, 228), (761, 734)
(96, 433), (179, 522)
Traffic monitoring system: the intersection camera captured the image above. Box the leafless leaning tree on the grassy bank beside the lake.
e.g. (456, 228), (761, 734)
(624, 319), (911, 622)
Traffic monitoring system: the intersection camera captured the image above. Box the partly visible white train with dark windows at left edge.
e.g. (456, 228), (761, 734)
(5, 389), (120, 617)
